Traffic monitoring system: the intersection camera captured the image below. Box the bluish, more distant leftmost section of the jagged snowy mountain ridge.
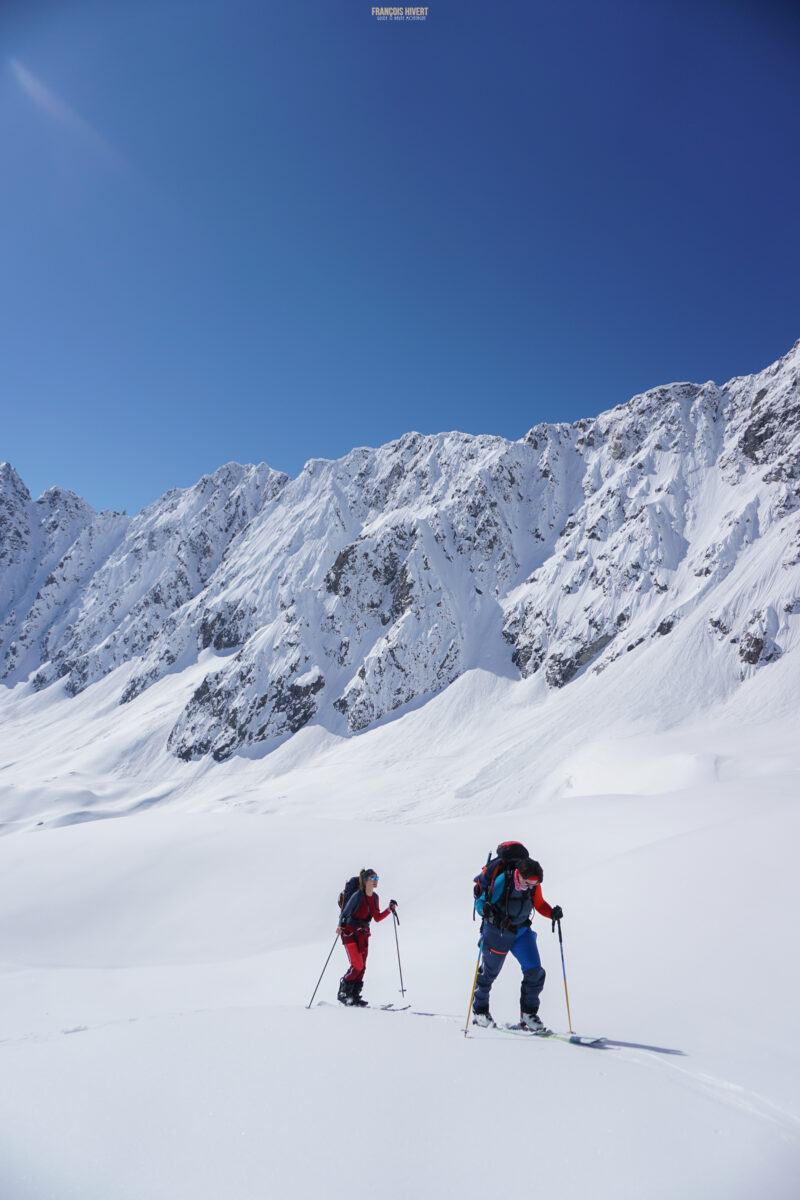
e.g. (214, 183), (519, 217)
(0, 463), (287, 695)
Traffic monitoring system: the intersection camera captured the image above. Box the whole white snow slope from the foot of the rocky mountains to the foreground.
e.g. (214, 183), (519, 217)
(0, 609), (800, 1200)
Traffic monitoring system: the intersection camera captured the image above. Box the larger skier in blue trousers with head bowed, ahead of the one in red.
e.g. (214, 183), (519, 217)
(473, 858), (564, 1033)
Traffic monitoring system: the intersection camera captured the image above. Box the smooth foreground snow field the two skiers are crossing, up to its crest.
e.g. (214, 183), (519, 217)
(0, 758), (800, 1200)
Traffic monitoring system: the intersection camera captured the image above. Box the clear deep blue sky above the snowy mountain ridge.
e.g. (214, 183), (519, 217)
(0, 0), (800, 511)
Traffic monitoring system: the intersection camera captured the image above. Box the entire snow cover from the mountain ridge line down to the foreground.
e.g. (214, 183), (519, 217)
(0, 347), (800, 1200)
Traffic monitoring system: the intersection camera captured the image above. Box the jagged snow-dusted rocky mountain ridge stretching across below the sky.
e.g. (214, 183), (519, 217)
(0, 342), (800, 760)
